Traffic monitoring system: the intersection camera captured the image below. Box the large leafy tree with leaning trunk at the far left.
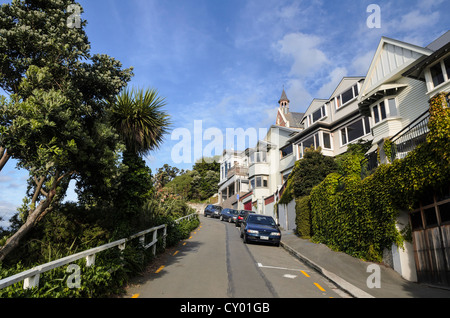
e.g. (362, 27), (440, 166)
(0, 0), (133, 262)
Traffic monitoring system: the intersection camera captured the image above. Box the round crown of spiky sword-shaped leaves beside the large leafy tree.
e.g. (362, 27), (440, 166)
(111, 89), (170, 155)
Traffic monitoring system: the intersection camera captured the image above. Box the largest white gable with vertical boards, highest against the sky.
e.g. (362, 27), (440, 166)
(359, 37), (433, 101)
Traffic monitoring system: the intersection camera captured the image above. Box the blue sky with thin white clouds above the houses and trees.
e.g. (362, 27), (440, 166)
(0, 0), (450, 229)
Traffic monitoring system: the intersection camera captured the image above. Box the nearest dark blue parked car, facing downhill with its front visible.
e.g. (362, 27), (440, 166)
(241, 214), (281, 246)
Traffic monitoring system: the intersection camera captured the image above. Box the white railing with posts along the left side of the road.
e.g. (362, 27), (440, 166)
(0, 213), (197, 289)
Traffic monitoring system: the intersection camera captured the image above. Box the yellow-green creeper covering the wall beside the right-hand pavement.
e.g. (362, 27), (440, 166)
(310, 94), (450, 261)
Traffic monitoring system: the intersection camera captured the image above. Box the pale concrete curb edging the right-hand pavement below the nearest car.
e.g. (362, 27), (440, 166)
(280, 241), (375, 298)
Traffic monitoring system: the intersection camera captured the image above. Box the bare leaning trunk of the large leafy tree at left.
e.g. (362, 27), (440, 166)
(0, 191), (55, 262)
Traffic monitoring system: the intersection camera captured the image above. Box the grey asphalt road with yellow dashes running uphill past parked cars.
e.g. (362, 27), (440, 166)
(125, 215), (347, 298)
